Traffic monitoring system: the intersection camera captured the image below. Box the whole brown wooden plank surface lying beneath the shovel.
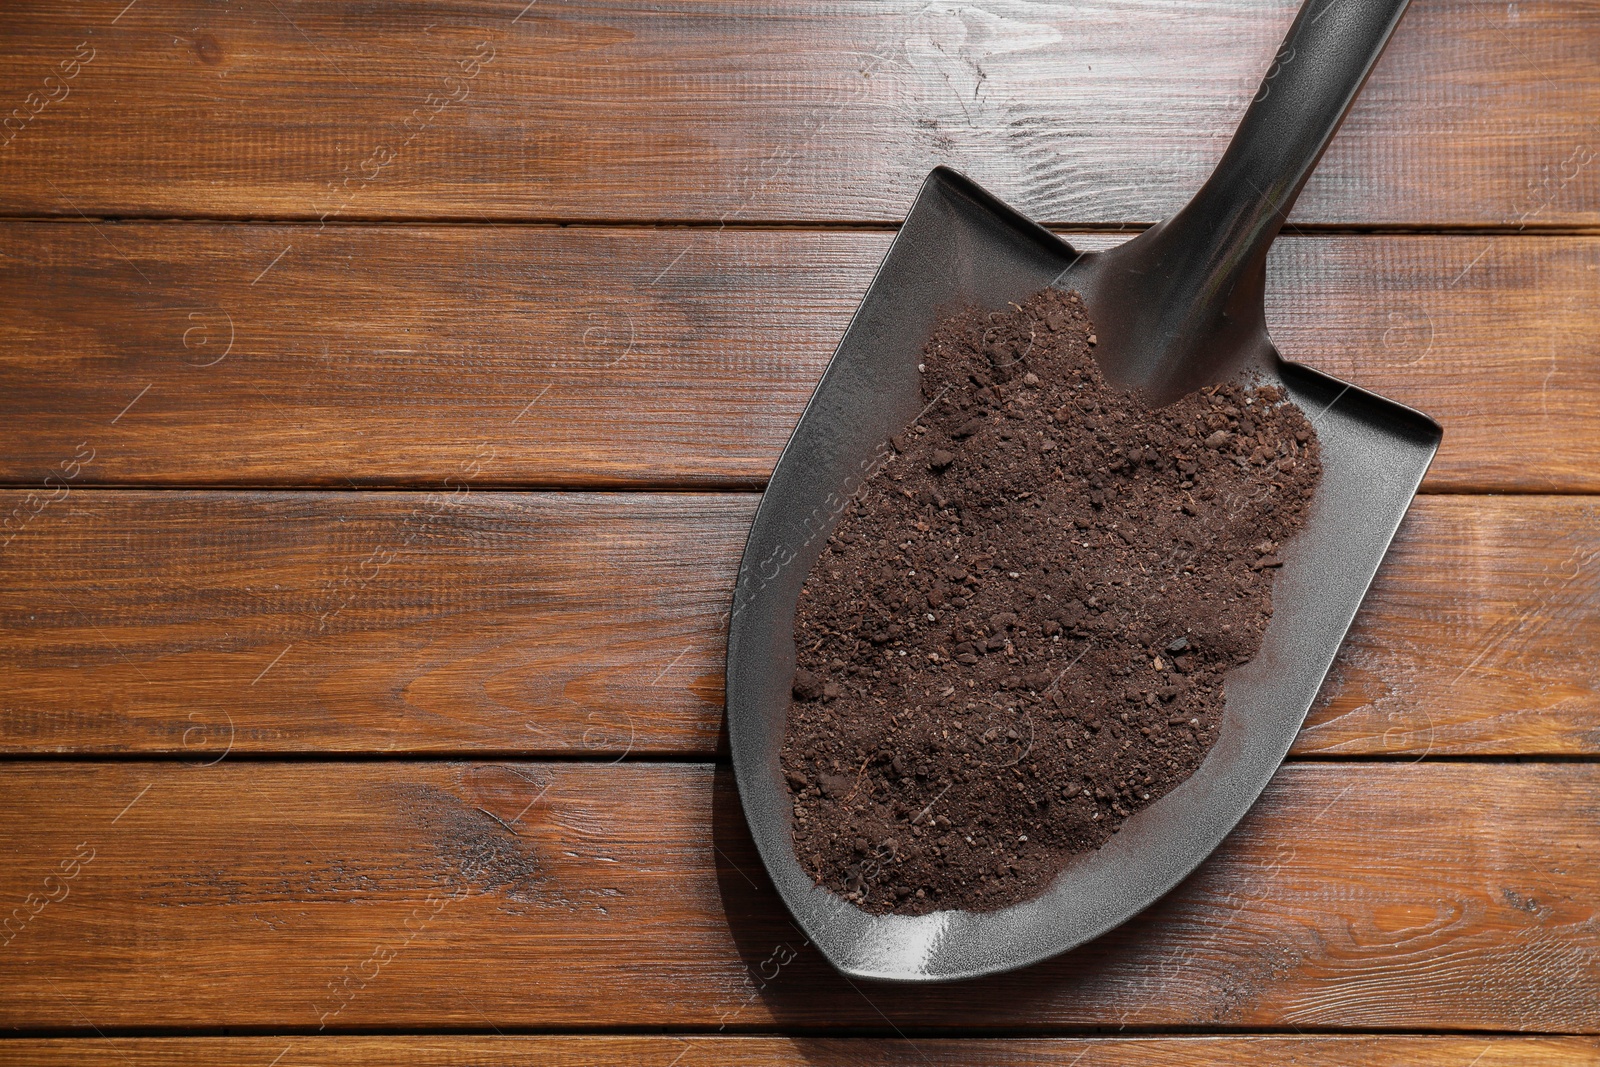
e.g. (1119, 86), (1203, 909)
(0, 0), (1600, 1067)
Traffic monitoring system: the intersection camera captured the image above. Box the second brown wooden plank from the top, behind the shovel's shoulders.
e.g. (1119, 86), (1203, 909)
(0, 227), (1600, 491)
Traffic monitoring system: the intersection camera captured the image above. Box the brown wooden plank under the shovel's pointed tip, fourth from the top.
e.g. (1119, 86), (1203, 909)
(0, 760), (1600, 1035)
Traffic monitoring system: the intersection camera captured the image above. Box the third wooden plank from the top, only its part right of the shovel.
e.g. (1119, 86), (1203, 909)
(1294, 496), (1600, 757)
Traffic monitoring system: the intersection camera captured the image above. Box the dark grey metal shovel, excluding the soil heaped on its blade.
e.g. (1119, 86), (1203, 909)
(728, 0), (1440, 982)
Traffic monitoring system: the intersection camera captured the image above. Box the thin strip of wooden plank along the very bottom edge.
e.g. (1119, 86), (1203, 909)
(0, 1035), (1600, 1067)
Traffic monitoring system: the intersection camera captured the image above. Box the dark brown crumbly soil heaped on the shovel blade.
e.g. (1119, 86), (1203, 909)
(782, 290), (1322, 915)
